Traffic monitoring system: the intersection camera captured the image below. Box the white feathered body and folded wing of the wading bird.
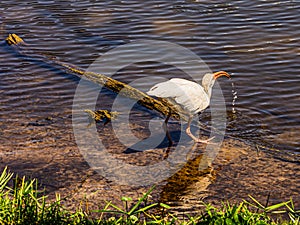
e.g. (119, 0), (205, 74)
(147, 78), (209, 114)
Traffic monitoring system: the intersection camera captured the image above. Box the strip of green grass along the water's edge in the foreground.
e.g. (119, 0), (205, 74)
(0, 168), (300, 225)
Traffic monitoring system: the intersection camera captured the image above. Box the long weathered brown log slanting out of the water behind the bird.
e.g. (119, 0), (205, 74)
(6, 34), (187, 120)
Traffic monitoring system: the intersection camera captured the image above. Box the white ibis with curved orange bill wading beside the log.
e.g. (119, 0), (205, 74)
(147, 71), (230, 143)
